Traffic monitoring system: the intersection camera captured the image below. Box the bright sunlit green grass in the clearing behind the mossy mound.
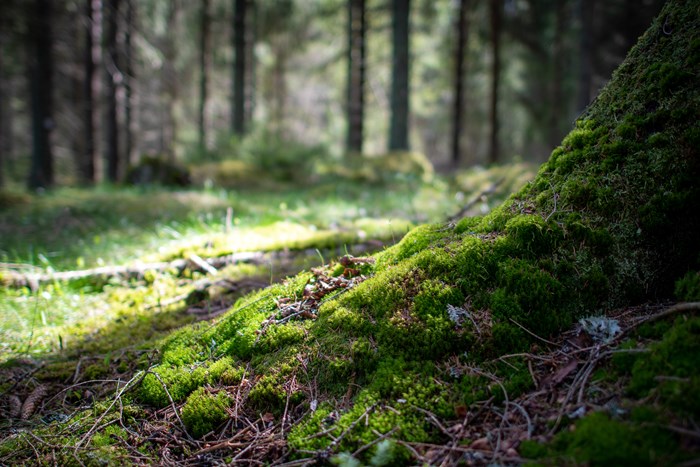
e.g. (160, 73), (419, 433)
(0, 165), (533, 360)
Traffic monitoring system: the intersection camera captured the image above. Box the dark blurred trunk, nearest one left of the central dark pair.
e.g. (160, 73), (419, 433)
(231, 0), (248, 136)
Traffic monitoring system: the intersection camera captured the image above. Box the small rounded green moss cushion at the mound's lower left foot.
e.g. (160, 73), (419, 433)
(181, 387), (231, 438)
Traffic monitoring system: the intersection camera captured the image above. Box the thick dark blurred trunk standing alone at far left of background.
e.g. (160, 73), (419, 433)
(27, 0), (54, 189)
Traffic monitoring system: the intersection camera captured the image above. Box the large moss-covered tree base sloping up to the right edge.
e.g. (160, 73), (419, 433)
(130, 0), (700, 462)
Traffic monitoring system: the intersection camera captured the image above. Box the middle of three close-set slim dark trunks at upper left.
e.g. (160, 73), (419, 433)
(104, 0), (122, 183)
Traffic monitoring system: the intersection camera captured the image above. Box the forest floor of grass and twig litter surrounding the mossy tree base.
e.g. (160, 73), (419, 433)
(0, 165), (697, 465)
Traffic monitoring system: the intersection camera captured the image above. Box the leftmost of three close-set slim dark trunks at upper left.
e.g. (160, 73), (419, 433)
(79, 0), (96, 184)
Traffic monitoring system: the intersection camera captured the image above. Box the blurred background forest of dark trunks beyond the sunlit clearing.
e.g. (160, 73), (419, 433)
(0, 0), (663, 188)
